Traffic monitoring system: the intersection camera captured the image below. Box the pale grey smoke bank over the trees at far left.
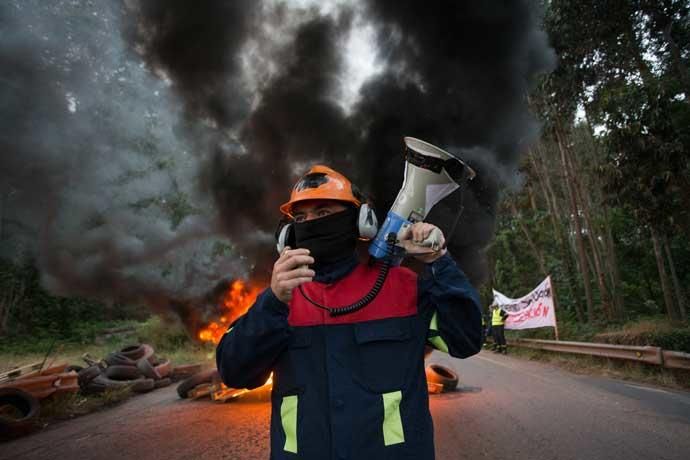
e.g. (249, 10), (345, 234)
(0, 0), (243, 314)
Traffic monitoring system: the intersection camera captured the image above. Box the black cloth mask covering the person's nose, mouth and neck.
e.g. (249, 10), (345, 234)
(293, 207), (359, 265)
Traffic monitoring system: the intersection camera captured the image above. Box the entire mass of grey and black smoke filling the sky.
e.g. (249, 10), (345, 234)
(0, 0), (554, 316)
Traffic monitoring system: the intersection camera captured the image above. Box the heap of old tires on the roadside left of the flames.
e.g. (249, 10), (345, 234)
(76, 344), (172, 393)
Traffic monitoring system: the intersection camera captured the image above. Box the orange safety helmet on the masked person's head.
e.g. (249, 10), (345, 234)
(280, 165), (362, 216)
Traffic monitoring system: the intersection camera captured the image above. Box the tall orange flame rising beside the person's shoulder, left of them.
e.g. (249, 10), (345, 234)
(197, 280), (263, 344)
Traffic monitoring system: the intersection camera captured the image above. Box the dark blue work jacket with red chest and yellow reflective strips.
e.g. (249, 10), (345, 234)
(216, 255), (482, 460)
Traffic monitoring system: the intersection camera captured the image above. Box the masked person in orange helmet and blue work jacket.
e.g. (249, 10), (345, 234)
(216, 166), (482, 460)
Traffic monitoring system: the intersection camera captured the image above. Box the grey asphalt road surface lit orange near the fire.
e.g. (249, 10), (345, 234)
(0, 352), (690, 460)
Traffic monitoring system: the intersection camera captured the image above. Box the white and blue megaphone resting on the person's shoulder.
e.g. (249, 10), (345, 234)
(369, 137), (476, 264)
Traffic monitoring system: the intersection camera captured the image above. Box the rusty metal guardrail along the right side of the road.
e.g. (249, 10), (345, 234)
(510, 339), (690, 369)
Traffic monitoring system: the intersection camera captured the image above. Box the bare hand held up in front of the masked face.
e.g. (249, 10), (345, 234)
(271, 246), (315, 303)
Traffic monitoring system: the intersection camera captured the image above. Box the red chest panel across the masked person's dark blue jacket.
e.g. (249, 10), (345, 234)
(288, 264), (417, 326)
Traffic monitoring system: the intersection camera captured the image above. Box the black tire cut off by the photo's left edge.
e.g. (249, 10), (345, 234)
(0, 388), (41, 441)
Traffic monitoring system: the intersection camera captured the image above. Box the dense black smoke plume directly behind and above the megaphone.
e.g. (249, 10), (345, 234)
(355, 0), (555, 281)
